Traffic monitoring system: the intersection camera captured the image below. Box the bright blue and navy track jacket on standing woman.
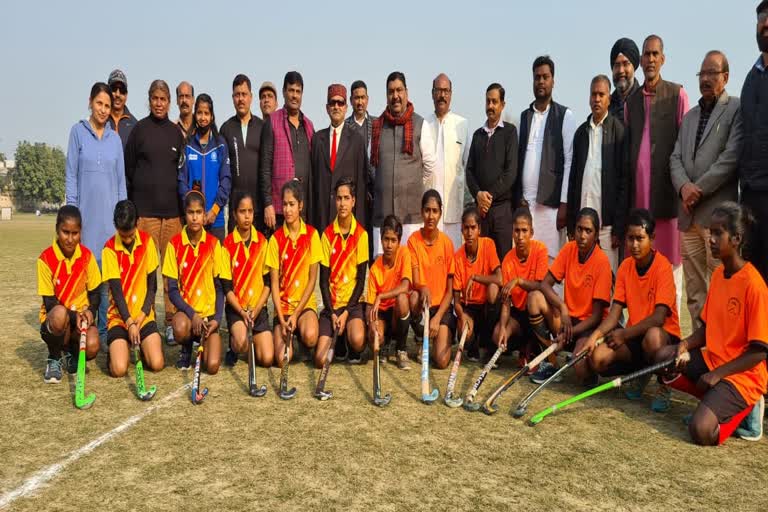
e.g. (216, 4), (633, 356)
(179, 134), (232, 228)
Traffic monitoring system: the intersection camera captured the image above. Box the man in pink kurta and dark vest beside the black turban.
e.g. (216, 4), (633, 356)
(624, 35), (688, 310)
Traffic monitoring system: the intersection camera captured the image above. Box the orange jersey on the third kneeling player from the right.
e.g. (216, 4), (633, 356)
(549, 242), (613, 320)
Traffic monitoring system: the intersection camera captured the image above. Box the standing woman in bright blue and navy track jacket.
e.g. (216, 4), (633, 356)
(179, 93), (232, 242)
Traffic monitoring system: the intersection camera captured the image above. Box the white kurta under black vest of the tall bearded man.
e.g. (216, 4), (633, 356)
(520, 103), (577, 204)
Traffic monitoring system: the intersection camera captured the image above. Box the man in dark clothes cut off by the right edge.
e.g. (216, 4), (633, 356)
(739, 0), (768, 281)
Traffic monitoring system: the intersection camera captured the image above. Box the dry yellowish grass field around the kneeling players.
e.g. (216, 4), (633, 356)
(0, 215), (768, 511)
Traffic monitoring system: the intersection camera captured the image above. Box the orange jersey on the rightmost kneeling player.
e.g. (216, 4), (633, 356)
(701, 263), (768, 405)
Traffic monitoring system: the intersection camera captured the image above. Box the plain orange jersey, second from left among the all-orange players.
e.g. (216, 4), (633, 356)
(408, 229), (456, 307)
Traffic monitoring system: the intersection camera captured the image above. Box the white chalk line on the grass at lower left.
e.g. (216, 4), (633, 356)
(0, 384), (189, 509)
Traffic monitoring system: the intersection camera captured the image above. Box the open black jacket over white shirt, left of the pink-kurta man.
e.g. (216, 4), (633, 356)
(567, 113), (629, 237)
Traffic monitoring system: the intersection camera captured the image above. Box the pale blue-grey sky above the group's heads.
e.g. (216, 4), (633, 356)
(0, 0), (759, 159)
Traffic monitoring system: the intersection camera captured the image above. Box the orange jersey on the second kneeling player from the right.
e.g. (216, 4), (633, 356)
(613, 251), (680, 338)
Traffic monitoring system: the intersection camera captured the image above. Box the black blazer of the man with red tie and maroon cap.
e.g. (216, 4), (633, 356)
(307, 126), (368, 232)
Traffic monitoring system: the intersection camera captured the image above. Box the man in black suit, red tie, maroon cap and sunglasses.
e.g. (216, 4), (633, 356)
(307, 84), (368, 230)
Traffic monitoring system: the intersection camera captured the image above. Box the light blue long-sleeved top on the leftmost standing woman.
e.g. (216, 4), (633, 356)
(64, 120), (127, 261)
